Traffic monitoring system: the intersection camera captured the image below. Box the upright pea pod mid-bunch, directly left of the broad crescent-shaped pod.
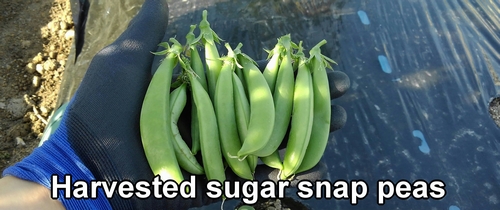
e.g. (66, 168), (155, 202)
(214, 56), (253, 180)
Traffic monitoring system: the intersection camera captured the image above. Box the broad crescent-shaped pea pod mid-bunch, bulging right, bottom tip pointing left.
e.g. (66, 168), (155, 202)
(234, 43), (275, 158)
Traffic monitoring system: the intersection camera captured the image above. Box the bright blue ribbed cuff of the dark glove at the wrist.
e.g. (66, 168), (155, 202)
(3, 115), (111, 209)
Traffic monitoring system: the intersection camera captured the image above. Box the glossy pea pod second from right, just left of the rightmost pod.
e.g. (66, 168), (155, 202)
(281, 58), (314, 179)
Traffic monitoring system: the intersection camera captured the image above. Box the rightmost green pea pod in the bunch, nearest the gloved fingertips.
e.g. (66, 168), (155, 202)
(296, 40), (334, 173)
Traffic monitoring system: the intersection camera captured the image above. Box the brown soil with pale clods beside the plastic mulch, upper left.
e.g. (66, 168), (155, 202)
(0, 0), (74, 171)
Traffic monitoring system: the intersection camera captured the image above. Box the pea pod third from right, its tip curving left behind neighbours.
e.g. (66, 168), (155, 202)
(253, 35), (294, 157)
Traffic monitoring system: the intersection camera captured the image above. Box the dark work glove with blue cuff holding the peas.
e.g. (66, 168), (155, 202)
(4, 0), (349, 209)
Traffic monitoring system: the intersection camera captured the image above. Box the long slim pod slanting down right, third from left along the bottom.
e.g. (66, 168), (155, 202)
(187, 66), (226, 183)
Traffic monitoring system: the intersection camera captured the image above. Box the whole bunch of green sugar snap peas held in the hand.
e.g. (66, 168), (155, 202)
(140, 11), (334, 183)
